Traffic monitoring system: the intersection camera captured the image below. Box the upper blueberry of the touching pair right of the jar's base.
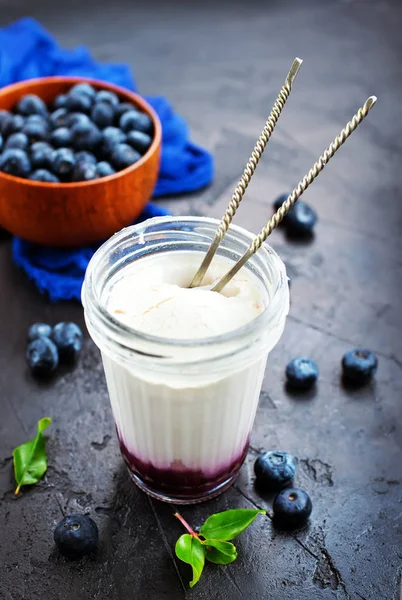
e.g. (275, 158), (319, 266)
(254, 450), (296, 490)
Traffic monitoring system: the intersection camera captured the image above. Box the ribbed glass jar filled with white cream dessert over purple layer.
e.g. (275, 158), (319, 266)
(82, 217), (289, 504)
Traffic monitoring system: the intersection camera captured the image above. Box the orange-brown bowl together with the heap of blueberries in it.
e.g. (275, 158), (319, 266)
(0, 77), (162, 247)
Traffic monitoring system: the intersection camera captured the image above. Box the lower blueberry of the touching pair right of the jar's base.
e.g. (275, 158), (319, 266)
(272, 488), (313, 529)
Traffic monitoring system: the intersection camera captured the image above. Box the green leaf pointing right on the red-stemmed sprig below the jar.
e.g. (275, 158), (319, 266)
(200, 508), (266, 541)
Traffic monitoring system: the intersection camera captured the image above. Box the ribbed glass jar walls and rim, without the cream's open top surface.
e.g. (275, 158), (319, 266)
(82, 216), (289, 504)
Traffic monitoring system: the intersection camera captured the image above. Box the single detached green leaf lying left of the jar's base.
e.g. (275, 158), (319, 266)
(13, 417), (52, 496)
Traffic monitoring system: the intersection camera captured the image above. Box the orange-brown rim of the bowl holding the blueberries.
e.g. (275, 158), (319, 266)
(0, 75), (162, 190)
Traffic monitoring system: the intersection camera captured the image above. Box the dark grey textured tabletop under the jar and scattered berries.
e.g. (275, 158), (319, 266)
(0, 0), (402, 600)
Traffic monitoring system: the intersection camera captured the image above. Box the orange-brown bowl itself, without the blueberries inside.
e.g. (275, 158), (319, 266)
(0, 77), (162, 246)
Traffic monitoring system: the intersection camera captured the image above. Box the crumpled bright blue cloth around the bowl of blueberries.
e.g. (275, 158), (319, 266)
(0, 18), (214, 301)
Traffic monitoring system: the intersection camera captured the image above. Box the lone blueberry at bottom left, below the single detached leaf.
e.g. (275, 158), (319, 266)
(53, 515), (99, 558)
